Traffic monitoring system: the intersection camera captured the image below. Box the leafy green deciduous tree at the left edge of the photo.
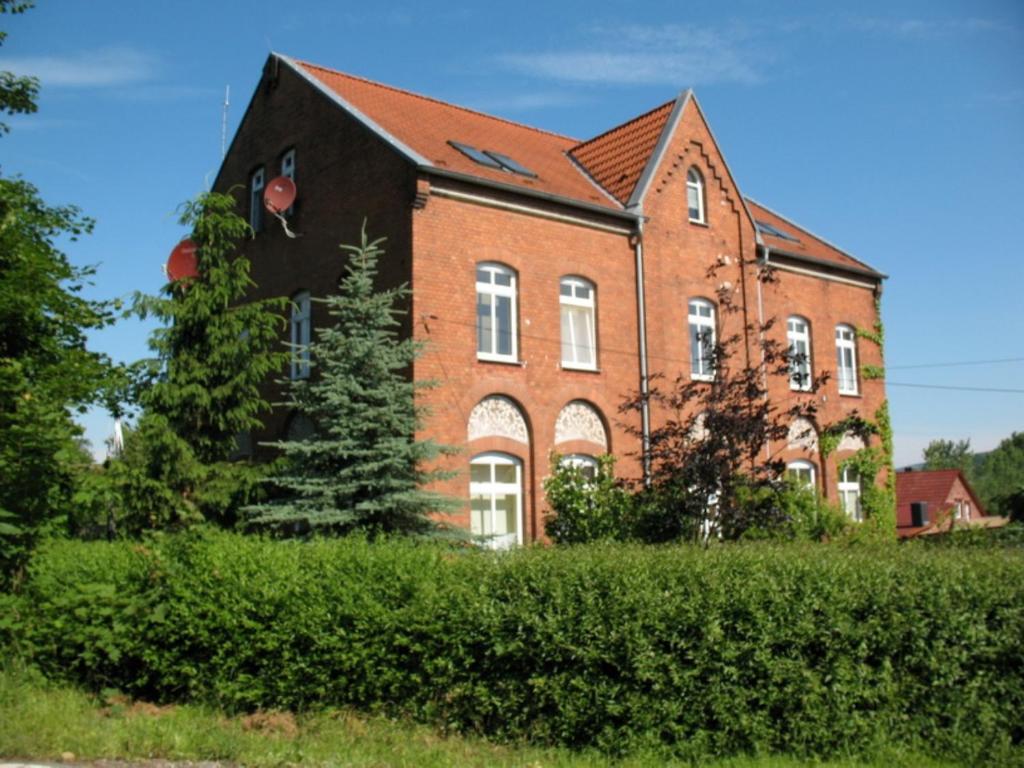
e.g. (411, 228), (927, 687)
(0, 178), (111, 581)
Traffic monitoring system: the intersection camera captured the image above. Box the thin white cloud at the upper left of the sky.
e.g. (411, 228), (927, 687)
(0, 48), (157, 88)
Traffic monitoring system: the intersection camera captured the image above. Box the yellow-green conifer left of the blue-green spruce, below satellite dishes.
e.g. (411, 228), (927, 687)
(93, 193), (288, 532)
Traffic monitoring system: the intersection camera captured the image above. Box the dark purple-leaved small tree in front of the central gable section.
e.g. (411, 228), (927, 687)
(620, 267), (827, 543)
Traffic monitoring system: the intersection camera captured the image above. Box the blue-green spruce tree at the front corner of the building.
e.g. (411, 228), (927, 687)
(249, 228), (454, 535)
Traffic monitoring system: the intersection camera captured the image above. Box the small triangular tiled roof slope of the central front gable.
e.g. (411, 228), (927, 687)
(570, 99), (677, 205)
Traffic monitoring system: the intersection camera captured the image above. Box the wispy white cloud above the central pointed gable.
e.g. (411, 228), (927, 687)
(498, 25), (766, 86)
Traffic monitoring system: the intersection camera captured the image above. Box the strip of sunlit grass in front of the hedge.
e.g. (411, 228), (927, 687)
(0, 666), (951, 768)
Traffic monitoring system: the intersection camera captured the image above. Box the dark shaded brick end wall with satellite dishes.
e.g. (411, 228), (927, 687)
(215, 65), (416, 448)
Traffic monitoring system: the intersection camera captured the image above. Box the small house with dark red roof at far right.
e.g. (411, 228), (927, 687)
(896, 469), (1007, 539)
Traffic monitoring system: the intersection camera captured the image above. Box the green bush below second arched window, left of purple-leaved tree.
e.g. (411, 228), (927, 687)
(544, 454), (635, 544)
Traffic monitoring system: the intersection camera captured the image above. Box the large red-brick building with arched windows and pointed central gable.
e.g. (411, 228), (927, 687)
(216, 54), (885, 542)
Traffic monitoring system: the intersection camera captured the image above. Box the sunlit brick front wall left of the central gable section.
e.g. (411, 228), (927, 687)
(413, 179), (639, 541)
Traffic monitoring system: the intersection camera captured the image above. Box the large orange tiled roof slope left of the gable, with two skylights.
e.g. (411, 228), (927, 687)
(282, 56), (622, 211)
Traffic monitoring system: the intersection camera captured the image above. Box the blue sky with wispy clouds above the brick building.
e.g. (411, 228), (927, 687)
(0, 0), (1024, 465)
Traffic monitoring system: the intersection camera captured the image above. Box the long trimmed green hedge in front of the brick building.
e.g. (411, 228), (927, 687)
(8, 534), (1024, 763)
